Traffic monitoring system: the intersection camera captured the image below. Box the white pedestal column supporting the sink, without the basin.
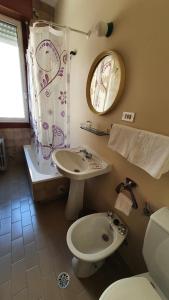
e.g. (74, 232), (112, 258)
(66, 179), (85, 221)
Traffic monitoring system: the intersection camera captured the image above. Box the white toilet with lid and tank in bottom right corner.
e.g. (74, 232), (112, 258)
(99, 207), (169, 300)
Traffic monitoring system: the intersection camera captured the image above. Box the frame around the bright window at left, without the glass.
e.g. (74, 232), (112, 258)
(0, 14), (29, 127)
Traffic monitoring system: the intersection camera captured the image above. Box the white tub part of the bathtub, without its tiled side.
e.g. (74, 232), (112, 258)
(24, 145), (62, 184)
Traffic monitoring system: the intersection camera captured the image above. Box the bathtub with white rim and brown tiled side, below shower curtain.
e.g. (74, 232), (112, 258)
(23, 145), (69, 201)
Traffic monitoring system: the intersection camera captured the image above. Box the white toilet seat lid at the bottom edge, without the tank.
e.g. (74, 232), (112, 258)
(99, 277), (162, 300)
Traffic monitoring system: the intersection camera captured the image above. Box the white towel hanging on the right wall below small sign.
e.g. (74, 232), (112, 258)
(108, 124), (169, 179)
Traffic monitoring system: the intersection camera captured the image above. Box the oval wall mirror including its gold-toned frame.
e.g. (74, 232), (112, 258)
(86, 50), (125, 115)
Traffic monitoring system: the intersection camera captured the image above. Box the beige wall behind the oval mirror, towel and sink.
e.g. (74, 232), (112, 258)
(55, 0), (169, 273)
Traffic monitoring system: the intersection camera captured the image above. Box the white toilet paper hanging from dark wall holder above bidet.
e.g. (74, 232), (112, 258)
(114, 193), (132, 216)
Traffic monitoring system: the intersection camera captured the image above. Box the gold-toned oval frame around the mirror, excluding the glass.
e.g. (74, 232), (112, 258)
(86, 50), (125, 115)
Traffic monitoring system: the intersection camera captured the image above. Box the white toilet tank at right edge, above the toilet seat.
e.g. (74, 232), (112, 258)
(143, 207), (169, 299)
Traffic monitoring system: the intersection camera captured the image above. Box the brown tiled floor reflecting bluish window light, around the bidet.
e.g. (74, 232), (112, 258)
(0, 161), (128, 300)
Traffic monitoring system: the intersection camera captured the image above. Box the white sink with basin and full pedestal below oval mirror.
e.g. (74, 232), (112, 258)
(52, 146), (111, 220)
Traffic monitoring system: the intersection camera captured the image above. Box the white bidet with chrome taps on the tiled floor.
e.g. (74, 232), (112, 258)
(67, 213), (127, 278)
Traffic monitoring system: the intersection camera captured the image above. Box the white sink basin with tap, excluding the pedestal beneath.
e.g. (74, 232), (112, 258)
(52, 146), (111, 180)
